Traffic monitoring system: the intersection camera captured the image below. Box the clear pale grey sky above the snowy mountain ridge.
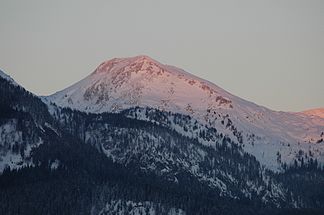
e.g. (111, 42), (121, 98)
(0, 0), (324, 111)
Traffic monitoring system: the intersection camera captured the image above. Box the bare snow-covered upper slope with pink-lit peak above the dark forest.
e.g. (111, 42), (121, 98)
(44, 56), (324, 170)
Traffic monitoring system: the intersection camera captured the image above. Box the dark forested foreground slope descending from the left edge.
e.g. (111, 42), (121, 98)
(0, 69), (223, 215)
